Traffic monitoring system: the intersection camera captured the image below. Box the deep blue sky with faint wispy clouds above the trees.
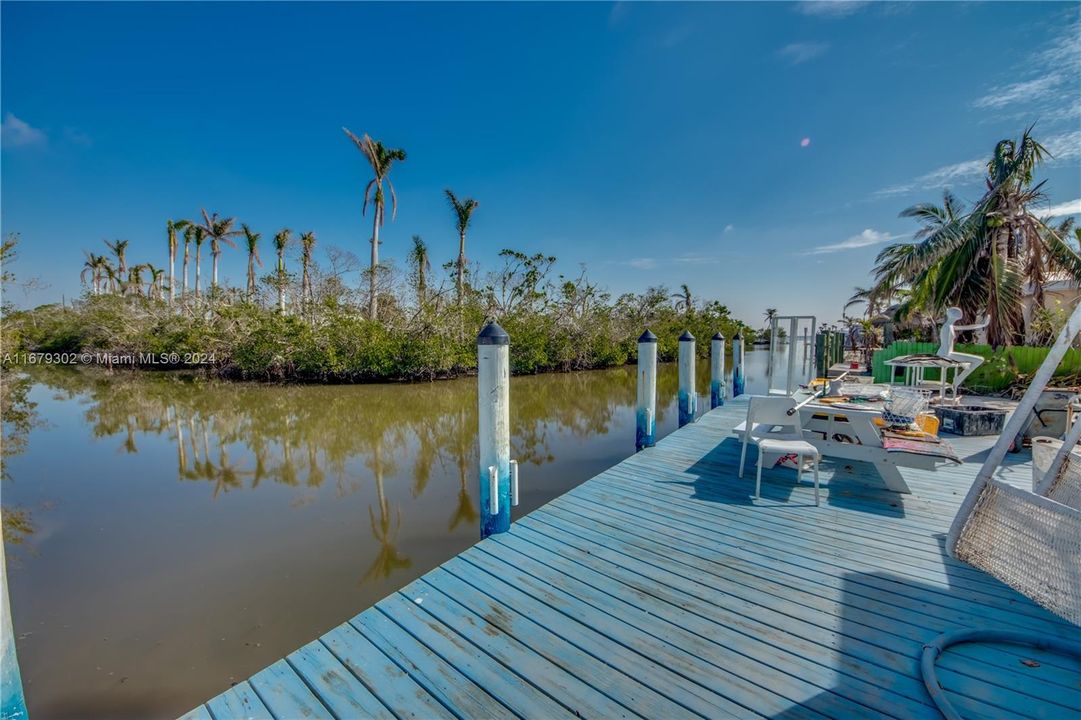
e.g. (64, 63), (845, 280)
(0, 2), (1081, 322)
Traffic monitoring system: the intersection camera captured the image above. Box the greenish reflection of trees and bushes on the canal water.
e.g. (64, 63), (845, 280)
(12, 368), (677, 582)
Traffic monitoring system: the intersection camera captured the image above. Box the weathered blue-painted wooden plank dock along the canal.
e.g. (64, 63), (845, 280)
(185, 398), (1081, 720)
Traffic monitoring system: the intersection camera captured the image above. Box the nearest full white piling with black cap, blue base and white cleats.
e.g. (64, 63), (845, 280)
(477, 322), (511, 538)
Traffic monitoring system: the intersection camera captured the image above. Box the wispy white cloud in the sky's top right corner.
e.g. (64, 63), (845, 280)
(973, 14), (1081, 115)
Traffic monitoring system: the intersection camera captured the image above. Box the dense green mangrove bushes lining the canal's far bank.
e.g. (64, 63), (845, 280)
(0, 235), (743, 382)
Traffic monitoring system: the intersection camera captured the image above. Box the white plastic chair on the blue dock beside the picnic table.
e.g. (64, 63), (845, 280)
(739, 398), (822, 505)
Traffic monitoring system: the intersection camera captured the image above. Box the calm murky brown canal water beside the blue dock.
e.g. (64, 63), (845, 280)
(2, 351), (804, 719)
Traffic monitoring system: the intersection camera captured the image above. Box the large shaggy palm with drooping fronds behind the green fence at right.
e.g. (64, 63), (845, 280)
(876, 128), (1081, 346)
